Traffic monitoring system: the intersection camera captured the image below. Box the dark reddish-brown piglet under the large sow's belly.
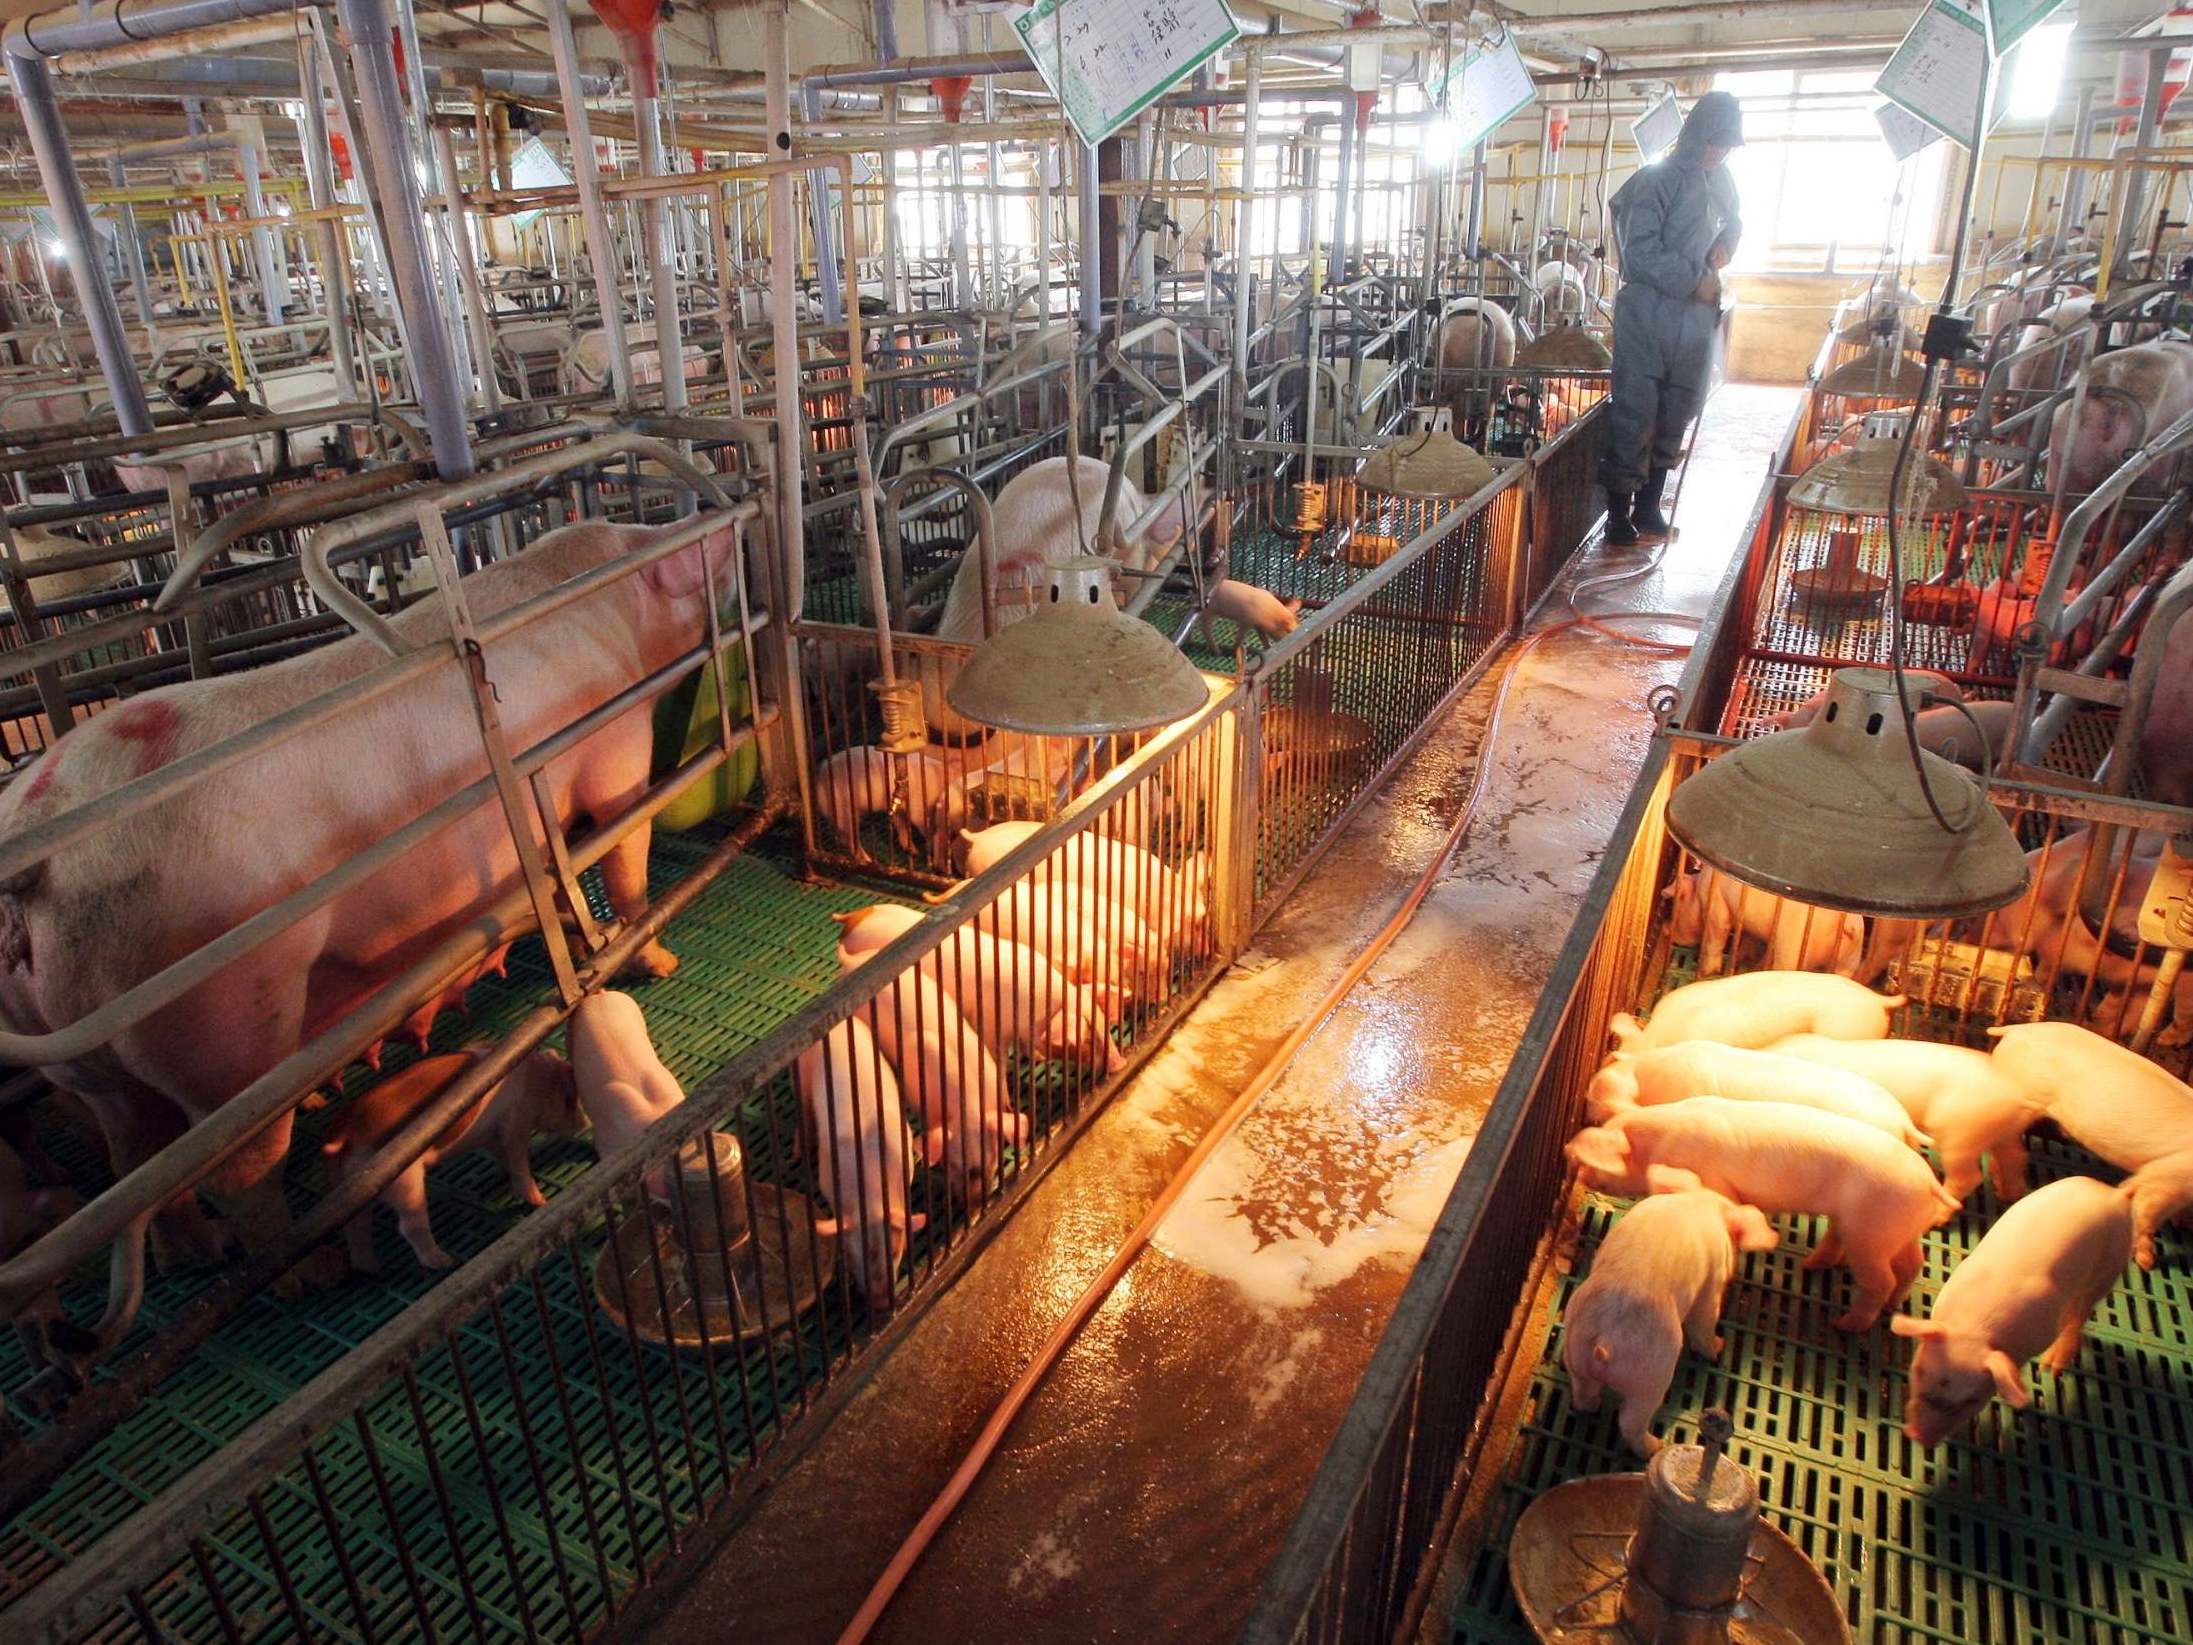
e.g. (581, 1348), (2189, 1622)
(320, 1048), (586, 1274)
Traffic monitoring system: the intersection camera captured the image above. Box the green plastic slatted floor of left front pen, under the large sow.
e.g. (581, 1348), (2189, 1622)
(0, 833), (912, 1641)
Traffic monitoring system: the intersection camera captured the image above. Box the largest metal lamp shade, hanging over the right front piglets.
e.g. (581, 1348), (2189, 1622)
(1667, 669), (2026, 919)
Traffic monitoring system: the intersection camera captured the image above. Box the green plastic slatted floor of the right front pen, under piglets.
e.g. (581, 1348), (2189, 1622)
(1454, 1143), (2193, 1645)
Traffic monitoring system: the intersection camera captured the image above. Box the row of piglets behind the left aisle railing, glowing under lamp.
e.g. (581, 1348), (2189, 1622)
(798, 823), (1211, 1307)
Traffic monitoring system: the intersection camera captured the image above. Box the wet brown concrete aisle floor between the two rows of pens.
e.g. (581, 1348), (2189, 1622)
(634, 388), (1796, 1645)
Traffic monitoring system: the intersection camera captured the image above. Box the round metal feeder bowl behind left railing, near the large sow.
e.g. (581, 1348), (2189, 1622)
(594, 1132), (838, 1349)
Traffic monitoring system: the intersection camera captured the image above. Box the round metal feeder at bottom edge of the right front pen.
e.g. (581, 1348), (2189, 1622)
(1509, 1410), (1851, 1645)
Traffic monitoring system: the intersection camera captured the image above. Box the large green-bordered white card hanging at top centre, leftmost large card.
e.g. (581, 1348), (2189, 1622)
(1013, 0), (1241, 145)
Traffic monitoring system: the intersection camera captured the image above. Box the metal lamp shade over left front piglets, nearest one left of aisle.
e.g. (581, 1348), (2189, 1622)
(945, 555), (1211, 737)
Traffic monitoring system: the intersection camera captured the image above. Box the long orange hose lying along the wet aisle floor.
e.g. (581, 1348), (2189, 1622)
(838, 612), (1578, 1645)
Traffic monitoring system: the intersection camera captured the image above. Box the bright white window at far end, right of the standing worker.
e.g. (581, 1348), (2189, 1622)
(1715, 70), (1950, 270)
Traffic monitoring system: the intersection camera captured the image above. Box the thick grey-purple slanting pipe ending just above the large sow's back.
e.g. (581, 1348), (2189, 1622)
(331, 0), (473, 480)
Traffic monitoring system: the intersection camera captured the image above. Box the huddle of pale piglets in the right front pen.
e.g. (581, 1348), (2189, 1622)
(1561, 972), (2193, 1456)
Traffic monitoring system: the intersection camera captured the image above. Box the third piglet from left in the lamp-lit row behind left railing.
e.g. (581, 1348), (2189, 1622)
(831, 910), (1127, 1073)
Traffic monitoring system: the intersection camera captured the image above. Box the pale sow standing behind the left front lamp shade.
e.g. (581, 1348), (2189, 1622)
(921, 456), (1186, 741)
